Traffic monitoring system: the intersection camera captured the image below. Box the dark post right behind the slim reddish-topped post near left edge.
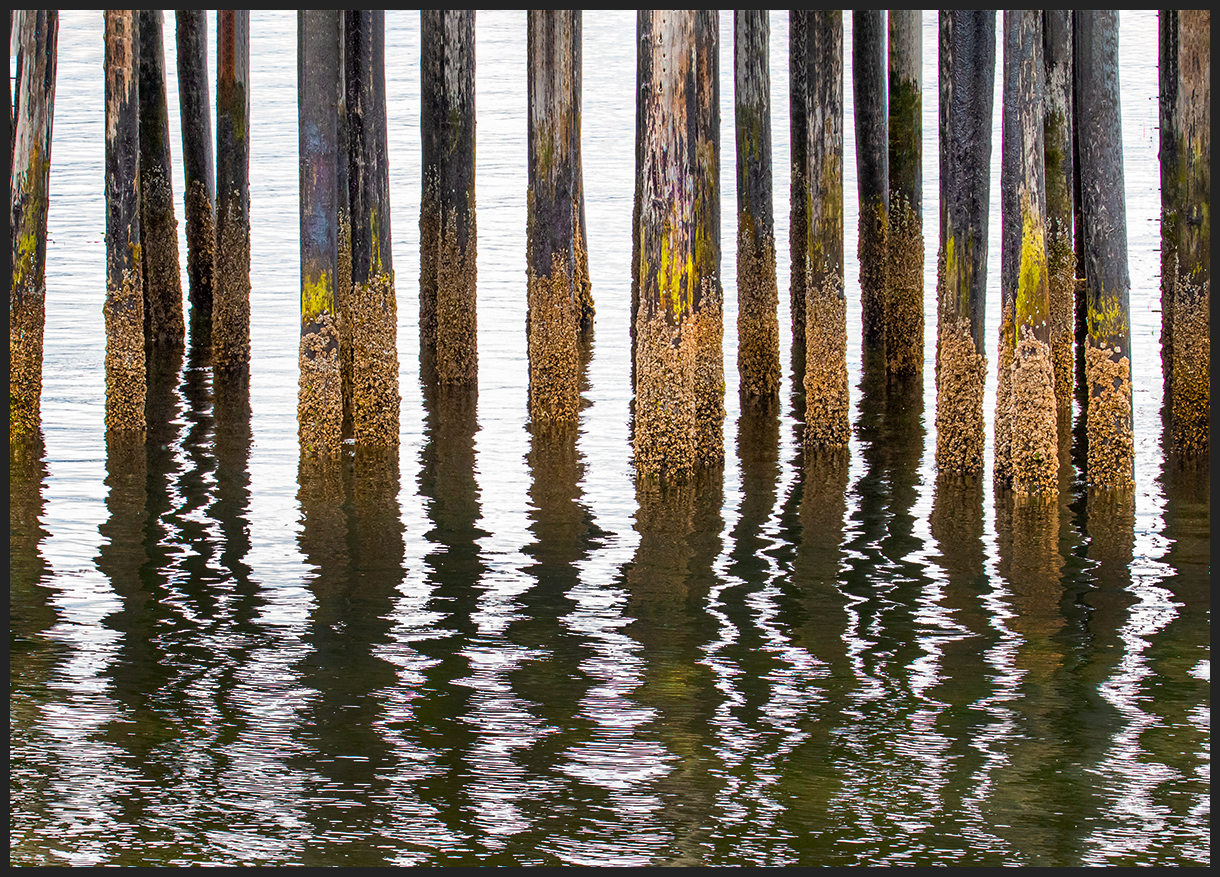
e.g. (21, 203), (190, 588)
(139, 10), (185, 346)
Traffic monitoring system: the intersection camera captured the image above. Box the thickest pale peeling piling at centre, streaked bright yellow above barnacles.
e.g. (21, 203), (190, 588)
(634, 10), (725, 476)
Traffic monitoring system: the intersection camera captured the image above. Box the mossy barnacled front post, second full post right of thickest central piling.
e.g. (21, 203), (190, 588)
(793, 10), (850, 449)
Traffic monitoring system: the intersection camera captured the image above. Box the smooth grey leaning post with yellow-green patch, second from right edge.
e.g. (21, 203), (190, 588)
(1074, 10), (1135, 489)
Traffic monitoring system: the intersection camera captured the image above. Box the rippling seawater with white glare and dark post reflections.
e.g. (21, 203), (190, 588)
(9, 10), (1211, 865)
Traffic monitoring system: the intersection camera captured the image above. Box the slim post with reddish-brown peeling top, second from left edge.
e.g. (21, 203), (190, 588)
(102, 10), (148, 433)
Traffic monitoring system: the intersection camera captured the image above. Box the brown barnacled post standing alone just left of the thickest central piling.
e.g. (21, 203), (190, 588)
(526, 10), (581, 421)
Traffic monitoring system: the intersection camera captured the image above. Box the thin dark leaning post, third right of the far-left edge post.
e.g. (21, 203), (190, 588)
(174, 10), (216, 334)
